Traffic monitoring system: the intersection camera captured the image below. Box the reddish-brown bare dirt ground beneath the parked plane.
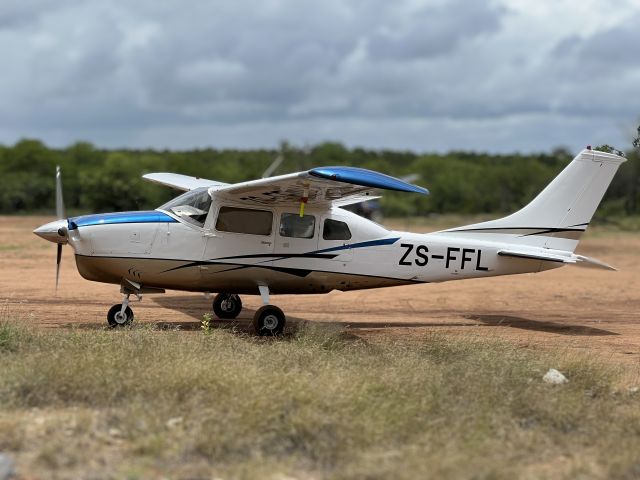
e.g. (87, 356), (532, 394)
(0, 217), (640, 376)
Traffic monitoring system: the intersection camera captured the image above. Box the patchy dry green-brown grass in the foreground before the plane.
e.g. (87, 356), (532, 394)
(0, 322), (640, 479)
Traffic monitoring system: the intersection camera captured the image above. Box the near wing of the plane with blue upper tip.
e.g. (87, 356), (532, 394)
(209, 167), (429, 207)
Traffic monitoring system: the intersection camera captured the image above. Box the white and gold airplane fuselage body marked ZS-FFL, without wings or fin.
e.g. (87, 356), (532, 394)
(62, 208), (561, 294)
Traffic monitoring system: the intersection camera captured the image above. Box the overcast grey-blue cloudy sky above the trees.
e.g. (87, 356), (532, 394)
(0, 0), (640, 152)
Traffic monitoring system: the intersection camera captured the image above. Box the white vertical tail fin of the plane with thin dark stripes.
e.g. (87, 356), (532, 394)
(447, 149), (626, 252)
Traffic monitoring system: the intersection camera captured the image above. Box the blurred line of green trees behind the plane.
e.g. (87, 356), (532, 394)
(0, 138), (640, 217)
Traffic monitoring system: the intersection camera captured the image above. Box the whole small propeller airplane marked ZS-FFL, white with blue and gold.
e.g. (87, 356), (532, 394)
(34, 147), (625, 335)
